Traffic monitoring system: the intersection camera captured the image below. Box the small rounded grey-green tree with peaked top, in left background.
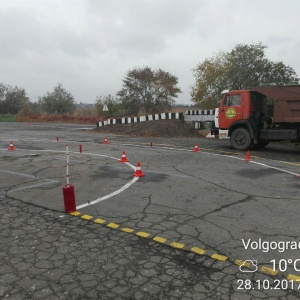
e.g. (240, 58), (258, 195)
(39, 83), (76, 115)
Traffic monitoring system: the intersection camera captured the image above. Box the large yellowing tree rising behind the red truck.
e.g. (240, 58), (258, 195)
(191, 42), (300, 108)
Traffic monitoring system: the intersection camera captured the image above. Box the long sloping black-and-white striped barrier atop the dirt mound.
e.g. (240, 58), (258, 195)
(97, 113), (184, 127)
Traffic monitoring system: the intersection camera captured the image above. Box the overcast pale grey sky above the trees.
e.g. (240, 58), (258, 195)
(0, 0), (300, 104)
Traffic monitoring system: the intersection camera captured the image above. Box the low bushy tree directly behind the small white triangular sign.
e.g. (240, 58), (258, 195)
(95, 95), (123, 117)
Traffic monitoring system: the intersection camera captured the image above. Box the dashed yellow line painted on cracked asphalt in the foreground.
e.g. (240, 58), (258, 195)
(70, 211), (300, 284)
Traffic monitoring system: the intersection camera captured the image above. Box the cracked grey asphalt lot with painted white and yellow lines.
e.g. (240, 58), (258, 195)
(0, 123), (300, 299)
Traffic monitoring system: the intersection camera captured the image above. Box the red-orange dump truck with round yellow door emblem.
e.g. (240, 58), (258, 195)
(211, 85), (300, 150)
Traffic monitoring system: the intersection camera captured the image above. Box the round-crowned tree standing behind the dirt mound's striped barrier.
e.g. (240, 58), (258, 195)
(117, 67), (181, 115)
